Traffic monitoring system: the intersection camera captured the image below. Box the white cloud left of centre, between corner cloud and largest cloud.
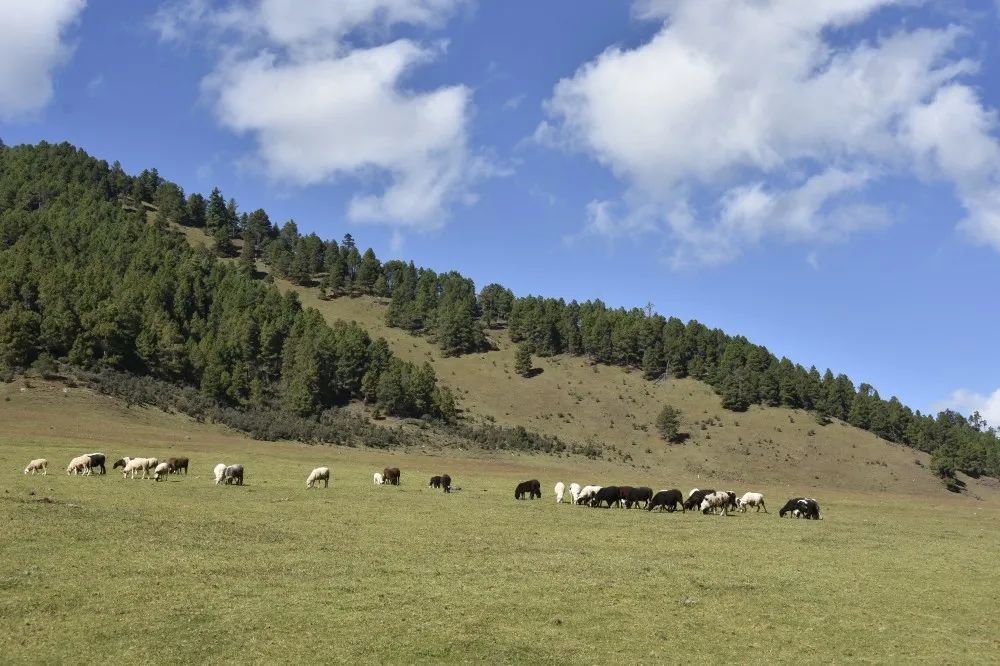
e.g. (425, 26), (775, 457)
(154, 0), (476, 229)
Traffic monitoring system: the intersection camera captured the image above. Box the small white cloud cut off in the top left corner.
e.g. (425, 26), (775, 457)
(0, 0), (86, 120)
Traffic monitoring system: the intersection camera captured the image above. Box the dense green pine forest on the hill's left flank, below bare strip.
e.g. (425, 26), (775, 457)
(0, 143), (457, 420)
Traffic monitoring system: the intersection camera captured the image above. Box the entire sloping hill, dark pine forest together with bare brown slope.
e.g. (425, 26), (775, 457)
(0, 144), (997, 496)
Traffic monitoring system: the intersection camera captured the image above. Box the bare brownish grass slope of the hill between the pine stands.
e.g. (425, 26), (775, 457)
(160, 215), (1000, 496)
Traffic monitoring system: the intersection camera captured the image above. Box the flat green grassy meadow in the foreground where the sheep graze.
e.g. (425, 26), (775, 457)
(0, 384), (1000, 663)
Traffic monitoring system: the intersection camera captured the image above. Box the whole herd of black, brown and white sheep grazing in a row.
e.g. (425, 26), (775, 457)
(24, 453), (822, 520)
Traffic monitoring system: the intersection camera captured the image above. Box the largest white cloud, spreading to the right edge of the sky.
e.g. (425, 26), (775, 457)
(536, 0), (1000, 265)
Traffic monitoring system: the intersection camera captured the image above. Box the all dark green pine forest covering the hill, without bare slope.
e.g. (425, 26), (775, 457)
(0, 144), (1000, 481)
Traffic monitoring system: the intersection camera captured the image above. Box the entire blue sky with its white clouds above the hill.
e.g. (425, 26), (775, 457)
(0, 0), (1000, 423)
